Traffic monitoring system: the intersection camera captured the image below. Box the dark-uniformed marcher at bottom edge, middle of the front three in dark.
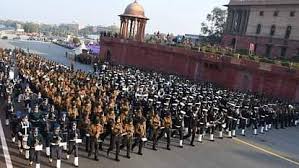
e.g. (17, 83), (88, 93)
(49, 123), (62, 168)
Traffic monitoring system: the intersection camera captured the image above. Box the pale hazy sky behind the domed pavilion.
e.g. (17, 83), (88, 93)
(0, 0), (229, 34)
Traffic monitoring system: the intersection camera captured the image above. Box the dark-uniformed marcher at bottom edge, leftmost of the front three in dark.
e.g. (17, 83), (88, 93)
(27, 127), (43, 168)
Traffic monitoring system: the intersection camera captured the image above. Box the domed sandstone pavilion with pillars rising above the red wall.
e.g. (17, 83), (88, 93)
(119, 1), (149, 42)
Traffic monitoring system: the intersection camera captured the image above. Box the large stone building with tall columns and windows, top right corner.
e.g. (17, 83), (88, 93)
(222, 0), (299, 58)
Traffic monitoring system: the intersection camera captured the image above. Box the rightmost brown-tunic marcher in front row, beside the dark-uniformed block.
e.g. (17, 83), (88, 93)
(158, 112), (172, 150)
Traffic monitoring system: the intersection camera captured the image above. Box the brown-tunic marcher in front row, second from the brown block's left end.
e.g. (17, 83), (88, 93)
(107, 117), (125, 161)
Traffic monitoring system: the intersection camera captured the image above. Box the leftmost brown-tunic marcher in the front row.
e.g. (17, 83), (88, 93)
(88, 119), (103, 161)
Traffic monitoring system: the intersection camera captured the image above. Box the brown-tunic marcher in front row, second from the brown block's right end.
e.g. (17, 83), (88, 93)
(151, 109), (161, 150)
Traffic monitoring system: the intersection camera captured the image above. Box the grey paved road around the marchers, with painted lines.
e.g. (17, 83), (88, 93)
(0, 39), (299, 168)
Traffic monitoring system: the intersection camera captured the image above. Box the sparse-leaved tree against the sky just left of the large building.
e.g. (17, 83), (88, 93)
(201, 7), (227, 43)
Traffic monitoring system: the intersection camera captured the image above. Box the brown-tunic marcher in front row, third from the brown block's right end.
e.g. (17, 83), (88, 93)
(132, 109), (146, 155)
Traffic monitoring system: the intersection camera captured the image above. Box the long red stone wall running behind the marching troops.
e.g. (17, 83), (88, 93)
(101, 38), (299, 102)
